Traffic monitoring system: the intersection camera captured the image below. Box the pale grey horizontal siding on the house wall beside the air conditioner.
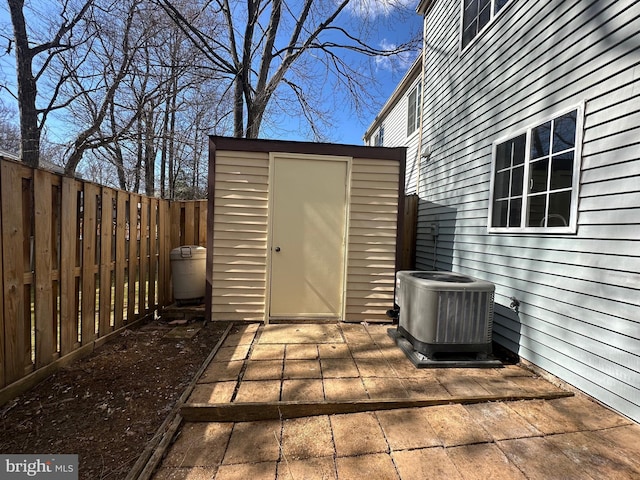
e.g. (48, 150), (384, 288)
(417, 0), (640, 421)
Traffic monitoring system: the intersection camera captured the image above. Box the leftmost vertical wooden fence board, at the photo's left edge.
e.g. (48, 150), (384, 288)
(1, 163), (27, 383)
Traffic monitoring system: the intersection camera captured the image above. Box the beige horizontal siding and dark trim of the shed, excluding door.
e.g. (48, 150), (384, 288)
(207, 137), (406, 322)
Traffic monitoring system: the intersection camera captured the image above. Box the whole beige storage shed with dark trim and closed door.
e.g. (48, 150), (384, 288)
(206, 136), (406, 323)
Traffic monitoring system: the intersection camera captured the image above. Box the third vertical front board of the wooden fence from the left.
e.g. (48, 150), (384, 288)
(60, 177), (79, 355)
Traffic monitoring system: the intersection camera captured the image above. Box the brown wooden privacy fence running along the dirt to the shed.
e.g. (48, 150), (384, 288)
(0, 159), (206, 405)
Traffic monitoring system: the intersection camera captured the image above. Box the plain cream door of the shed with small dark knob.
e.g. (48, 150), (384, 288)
(269, 157), (348, 319)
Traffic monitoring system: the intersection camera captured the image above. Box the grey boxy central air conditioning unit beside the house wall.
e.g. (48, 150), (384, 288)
(395, 271), (495, 358)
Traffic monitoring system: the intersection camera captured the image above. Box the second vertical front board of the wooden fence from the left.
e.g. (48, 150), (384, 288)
(33, 170), (57, 368)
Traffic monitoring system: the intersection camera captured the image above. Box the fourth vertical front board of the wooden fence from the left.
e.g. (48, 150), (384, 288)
(81, 183), (100, 345)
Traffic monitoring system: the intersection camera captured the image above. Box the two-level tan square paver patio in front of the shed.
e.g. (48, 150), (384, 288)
(154, 324), (640, 480)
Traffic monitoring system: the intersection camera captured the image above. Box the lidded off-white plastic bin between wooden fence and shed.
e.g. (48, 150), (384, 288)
(170, 245), (207, 303)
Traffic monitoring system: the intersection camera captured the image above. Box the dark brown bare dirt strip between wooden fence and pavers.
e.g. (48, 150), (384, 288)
(0, 320), (227, 480)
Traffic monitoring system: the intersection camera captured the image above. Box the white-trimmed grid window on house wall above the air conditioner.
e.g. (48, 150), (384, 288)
(489, 109), (580, 233)
